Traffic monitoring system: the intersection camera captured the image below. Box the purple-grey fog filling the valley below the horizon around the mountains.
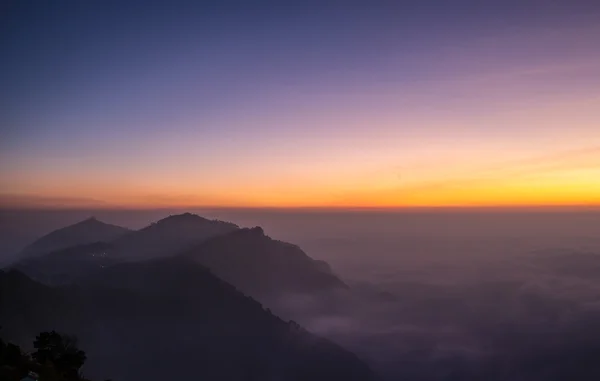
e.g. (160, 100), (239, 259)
(2, 210), (600, 381)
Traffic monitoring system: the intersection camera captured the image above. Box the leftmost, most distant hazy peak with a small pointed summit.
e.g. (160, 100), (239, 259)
(19, 217), (131, 258)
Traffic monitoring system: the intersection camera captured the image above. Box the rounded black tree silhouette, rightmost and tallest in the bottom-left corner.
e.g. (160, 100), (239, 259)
(31, 331), (87, 378)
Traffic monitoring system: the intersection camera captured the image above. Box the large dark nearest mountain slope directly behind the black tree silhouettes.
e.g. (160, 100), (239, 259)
(0, 257), (374, 381)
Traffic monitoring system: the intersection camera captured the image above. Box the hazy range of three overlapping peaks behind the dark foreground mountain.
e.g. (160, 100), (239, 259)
(14, 213), (347, 298)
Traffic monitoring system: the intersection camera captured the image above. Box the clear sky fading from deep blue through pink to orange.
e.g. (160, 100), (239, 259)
(0, 0), (600, 207)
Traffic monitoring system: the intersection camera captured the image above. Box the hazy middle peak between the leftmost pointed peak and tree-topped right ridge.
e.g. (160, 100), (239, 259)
(114, 213), (239, 259)
